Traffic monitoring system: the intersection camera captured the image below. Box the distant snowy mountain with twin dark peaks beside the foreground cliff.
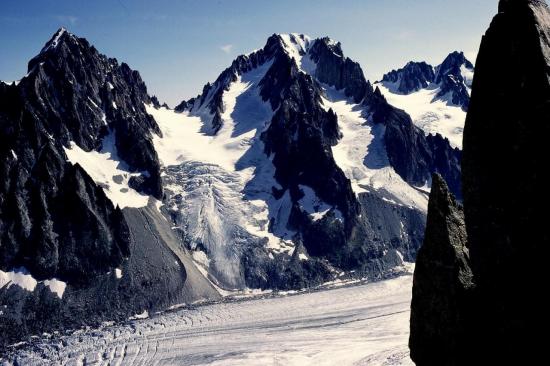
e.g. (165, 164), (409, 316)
(375, 52), (474, 148)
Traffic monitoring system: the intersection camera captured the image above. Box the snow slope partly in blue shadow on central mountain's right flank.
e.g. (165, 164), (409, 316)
(323, 86), (428, 212)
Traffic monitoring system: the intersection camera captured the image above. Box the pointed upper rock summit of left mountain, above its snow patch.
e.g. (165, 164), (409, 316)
(19, 28), (162, 198)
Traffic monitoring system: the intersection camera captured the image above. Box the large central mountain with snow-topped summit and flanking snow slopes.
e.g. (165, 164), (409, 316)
(148, 34), (460, 287)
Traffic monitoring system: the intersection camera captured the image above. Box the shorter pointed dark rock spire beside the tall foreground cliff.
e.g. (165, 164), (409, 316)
(410, 175), (474, 365)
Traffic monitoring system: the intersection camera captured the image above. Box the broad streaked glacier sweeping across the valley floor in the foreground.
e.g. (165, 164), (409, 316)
(4, 274), (413, 366)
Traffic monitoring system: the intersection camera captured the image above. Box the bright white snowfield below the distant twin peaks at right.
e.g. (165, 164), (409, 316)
(377, 81), (473, 149)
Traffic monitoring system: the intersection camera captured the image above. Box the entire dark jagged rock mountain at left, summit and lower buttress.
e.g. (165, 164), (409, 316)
(0, 28), (169, 285)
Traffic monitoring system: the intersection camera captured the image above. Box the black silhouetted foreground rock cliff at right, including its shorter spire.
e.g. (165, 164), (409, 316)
(411, 0), (550, 365)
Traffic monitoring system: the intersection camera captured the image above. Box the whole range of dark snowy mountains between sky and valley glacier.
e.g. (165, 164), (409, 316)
(0, 29), (473, 343)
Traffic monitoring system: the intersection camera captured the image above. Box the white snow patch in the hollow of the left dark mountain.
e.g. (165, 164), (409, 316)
(65, 132), (149, 208)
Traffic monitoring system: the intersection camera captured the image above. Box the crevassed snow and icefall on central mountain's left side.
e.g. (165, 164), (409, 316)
(146, 62), (302, 289)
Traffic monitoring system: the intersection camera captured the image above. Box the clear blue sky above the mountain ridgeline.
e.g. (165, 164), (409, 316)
(0, 0), (498, 105)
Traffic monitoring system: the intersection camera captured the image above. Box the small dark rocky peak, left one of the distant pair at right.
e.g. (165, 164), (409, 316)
(382, 62), (435, 94)
